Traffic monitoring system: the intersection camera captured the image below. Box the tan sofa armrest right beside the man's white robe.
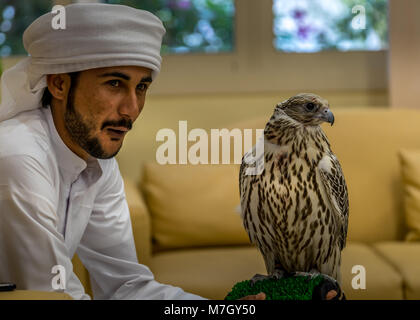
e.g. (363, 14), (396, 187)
(124, 177), (152, 265)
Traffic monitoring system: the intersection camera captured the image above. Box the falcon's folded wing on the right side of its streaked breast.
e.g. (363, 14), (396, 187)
(319, 155), (349, 250)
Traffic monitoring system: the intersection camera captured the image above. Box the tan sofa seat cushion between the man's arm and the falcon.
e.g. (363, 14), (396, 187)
(150, 246), (266, 300)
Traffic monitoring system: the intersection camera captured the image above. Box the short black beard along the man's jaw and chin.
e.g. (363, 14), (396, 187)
(64, 86), (122, 159)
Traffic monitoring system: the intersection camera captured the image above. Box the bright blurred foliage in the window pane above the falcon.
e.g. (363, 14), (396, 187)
(273, 0), (388, 52)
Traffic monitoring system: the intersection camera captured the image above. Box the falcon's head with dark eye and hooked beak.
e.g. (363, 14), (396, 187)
(274, 93), (334, 126)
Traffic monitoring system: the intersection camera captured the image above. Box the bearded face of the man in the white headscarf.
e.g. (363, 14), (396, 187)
(64, 66), (152, 159)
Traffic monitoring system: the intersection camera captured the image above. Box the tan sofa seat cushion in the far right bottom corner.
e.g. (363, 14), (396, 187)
(374, 242), (420, 300)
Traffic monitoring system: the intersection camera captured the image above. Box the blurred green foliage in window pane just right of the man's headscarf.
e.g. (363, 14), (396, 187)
(102, 0), (235, 54)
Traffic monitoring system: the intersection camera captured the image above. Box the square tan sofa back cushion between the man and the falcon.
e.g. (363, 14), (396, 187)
(142, 163), (249, 251)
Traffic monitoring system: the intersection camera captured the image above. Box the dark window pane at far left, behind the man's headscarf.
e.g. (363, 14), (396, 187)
(0, 0), (52, 57)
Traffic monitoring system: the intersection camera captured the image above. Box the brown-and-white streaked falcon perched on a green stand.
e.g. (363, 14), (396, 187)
(239, 93), (349, 292)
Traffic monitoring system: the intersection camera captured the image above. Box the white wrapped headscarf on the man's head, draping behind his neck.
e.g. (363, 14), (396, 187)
(0, 3), (165, 121)
